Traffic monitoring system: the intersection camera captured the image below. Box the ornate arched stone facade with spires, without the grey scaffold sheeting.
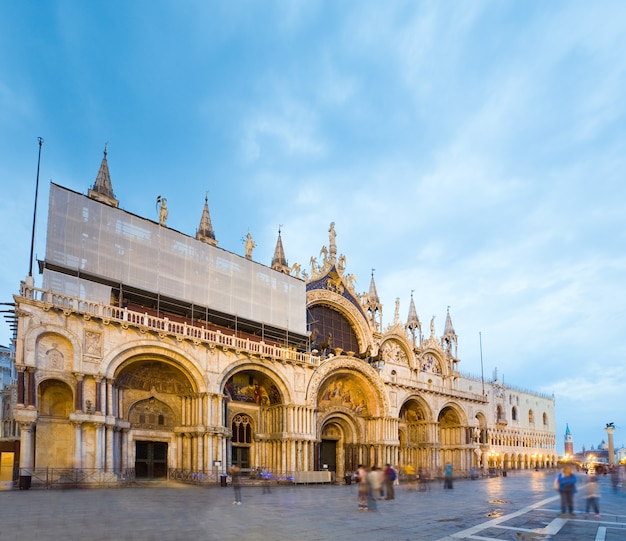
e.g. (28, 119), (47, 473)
(8, 155), (557, 481)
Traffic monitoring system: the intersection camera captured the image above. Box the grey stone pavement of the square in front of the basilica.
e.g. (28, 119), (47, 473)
(0, 471), (626, 541)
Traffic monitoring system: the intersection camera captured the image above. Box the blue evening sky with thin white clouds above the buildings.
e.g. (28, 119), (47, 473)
(0, 0), (626, 453)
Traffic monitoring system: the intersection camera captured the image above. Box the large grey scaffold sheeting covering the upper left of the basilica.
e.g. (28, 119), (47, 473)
(46, 184), (306, 335)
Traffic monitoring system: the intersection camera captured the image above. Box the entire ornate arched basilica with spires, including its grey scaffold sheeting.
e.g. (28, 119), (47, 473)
(12, 151), (557, 483)
